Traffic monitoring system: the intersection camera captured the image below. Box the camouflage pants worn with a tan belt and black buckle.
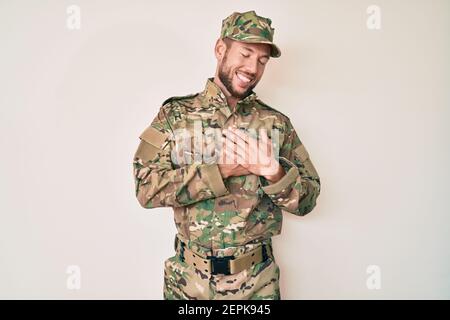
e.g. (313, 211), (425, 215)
(163, 235), (281, 300)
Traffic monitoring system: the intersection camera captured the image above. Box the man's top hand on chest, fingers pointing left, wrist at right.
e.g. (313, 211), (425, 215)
(223, 128), (285, 183)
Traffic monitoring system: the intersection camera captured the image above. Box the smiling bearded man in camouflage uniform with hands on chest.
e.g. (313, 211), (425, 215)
(133, 11), (320, 299)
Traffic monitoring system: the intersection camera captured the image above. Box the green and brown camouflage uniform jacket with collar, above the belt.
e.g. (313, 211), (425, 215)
(133, 78), (320, 249)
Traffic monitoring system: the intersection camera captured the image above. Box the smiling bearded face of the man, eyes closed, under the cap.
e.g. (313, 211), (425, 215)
(218, 40), (270, 99)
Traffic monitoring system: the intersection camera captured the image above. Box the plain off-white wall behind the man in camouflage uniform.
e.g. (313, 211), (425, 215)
(0, 0), (450, 299)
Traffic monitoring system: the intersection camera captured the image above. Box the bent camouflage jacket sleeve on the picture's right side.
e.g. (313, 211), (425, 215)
(262, 121), (320, 216)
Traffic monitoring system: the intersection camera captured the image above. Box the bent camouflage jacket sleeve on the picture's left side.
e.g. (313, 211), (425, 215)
(133, 107), (228, 208)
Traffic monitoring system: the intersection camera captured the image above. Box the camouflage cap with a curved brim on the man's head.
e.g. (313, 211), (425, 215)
(220, 10), (281, 58)
